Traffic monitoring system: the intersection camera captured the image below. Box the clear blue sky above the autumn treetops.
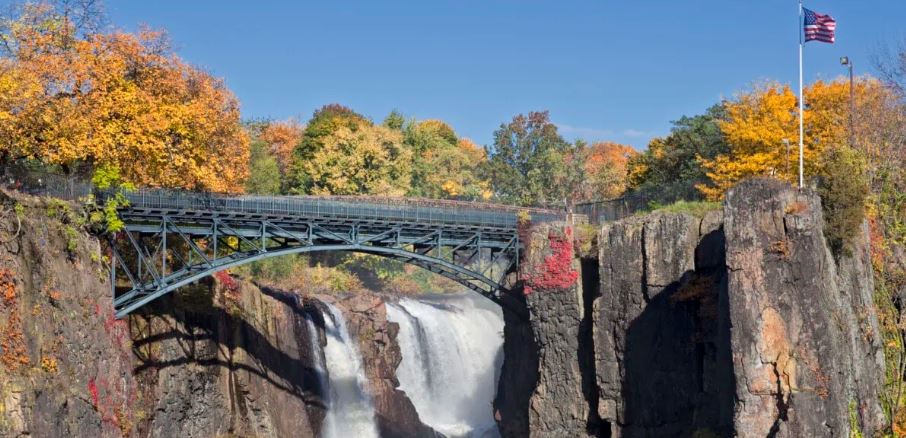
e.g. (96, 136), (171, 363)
(100, 0), (906, 148)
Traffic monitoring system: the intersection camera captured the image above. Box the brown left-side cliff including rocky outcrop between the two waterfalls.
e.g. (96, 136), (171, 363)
(0, 189), (434, 437)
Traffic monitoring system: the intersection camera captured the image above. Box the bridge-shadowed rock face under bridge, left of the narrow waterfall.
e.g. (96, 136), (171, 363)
(131, 276), (325, 437)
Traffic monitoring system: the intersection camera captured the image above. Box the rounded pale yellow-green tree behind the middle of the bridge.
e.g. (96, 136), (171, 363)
(290, 104), (412, 196)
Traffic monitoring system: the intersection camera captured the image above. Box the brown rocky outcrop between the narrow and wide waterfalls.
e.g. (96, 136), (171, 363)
(319, 293), (437, 438)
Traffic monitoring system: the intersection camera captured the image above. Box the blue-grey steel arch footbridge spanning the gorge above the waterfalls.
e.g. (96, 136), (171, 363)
(106, 190), (559, 318)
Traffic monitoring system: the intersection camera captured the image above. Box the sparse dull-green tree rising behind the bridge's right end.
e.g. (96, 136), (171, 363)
(486, 111), (571, 206)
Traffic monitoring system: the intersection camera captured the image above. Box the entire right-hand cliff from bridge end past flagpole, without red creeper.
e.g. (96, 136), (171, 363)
(496, 180), (885, 437)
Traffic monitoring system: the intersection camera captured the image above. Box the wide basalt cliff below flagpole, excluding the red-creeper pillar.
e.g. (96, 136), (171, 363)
(594, 180), (884, 437)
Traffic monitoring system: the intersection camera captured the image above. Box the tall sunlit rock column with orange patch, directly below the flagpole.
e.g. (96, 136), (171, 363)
(725, 181), (884, 437)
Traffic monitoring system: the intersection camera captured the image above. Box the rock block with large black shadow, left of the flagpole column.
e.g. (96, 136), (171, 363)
(594, 212), (733, 436)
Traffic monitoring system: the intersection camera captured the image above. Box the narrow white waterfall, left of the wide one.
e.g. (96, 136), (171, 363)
(321, 304), (378, 438)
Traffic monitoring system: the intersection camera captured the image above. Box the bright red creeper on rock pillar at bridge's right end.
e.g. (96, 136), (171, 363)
(522, 227), (579, 295)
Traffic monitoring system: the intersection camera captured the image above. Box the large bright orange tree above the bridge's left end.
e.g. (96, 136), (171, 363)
(0, 2), (249, 192)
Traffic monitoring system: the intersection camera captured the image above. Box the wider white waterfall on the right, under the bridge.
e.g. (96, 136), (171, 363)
(387, 294), (503, 438)
